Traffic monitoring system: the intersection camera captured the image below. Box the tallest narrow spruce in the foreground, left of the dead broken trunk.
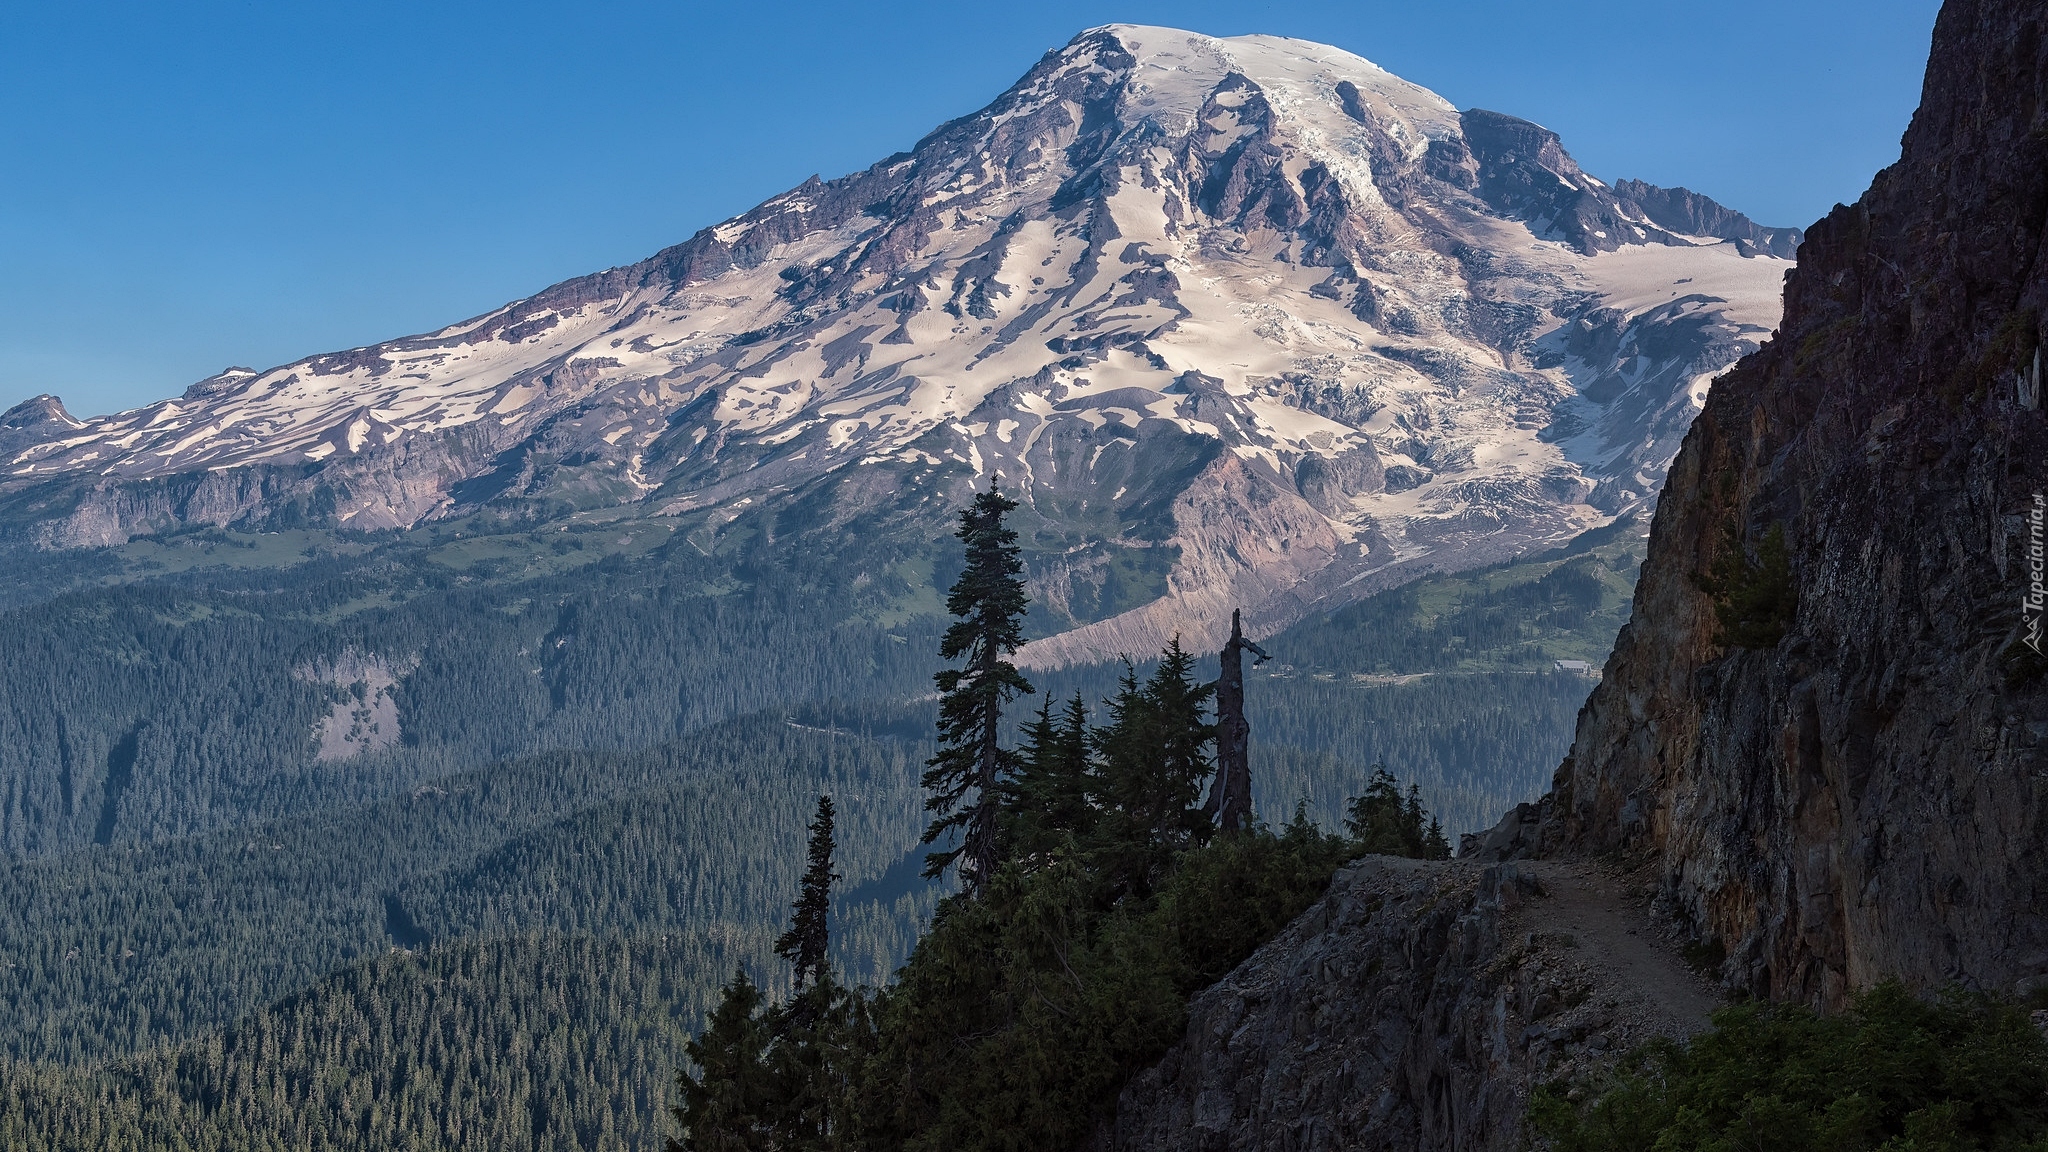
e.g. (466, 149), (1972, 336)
(924, 480), (1032, 894)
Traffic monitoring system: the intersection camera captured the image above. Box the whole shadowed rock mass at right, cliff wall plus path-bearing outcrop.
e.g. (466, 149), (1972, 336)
(1098, 0), (2048, 1150)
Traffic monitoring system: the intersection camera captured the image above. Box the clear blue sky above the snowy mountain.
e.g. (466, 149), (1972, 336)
(0, 0), (1935, 414)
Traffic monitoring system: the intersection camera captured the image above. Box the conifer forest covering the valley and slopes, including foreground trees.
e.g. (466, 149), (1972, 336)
(0, 498), (1640, 1150)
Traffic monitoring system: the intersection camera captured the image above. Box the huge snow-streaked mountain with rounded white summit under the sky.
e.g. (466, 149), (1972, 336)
(0, 25), (1798, 660)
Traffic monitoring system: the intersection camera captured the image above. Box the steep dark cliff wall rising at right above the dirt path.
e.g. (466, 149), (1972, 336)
(1470, 0), (2048, 1004)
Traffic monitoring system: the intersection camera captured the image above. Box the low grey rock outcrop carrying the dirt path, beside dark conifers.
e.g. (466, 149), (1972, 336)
(1094, 857), (1714, 1152)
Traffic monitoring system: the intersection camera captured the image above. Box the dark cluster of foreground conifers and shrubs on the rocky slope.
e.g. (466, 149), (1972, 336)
(672, 486), (1450, 1152)
